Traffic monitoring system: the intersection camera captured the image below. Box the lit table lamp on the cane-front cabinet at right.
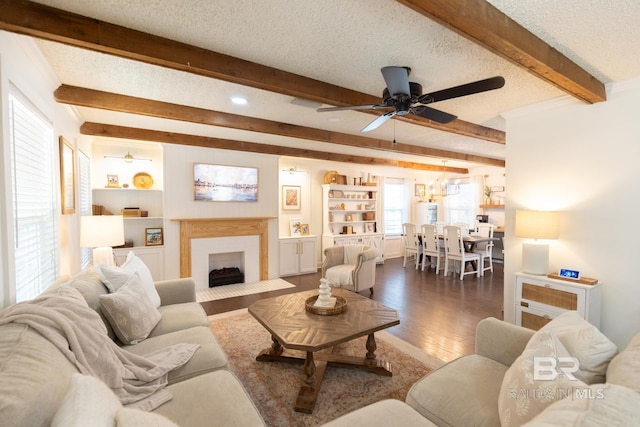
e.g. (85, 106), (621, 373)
(516, 210), (558, 275)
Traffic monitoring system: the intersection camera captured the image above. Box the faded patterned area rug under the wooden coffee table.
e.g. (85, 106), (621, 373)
(209, 309), (443, 427)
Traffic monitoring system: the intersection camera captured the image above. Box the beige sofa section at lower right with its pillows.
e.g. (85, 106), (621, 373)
(406, 311), (640, 427)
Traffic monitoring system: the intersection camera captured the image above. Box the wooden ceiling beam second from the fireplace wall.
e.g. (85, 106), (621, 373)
(54, 85), (505, 167)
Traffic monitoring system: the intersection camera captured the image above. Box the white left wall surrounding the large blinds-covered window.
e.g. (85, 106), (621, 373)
(0, 31), (82, 307)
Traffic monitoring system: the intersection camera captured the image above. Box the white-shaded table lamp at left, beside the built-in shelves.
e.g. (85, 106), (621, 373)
(80, 215), (124, 266)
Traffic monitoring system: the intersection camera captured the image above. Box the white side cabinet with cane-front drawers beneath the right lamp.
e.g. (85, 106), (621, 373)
(515, 273), (602, 330)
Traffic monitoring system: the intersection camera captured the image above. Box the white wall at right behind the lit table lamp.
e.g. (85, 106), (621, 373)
(504, 78), (640, 347)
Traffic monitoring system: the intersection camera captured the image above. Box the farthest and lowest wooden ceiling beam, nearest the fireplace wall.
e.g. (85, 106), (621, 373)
(80, 122), (469, 174)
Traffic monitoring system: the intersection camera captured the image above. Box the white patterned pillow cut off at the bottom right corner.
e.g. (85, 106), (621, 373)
(525, 384), (640, 427)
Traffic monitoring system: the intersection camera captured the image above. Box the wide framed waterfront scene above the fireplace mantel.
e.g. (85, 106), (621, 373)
(193, 163), (258, 202)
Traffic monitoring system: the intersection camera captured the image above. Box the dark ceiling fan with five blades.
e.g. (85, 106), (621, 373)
(317, 66), (504, 132)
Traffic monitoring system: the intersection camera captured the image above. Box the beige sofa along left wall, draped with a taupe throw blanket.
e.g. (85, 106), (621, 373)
(0, 254), (265, 427)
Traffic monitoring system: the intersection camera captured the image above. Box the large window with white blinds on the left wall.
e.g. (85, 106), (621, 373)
(9, 94), (58, 302)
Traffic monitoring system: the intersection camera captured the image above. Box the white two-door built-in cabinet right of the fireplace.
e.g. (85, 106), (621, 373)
(280, 236), (318, 277)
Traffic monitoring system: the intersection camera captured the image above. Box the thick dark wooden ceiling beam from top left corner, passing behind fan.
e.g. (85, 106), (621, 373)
(0, 0), (506, 144)
